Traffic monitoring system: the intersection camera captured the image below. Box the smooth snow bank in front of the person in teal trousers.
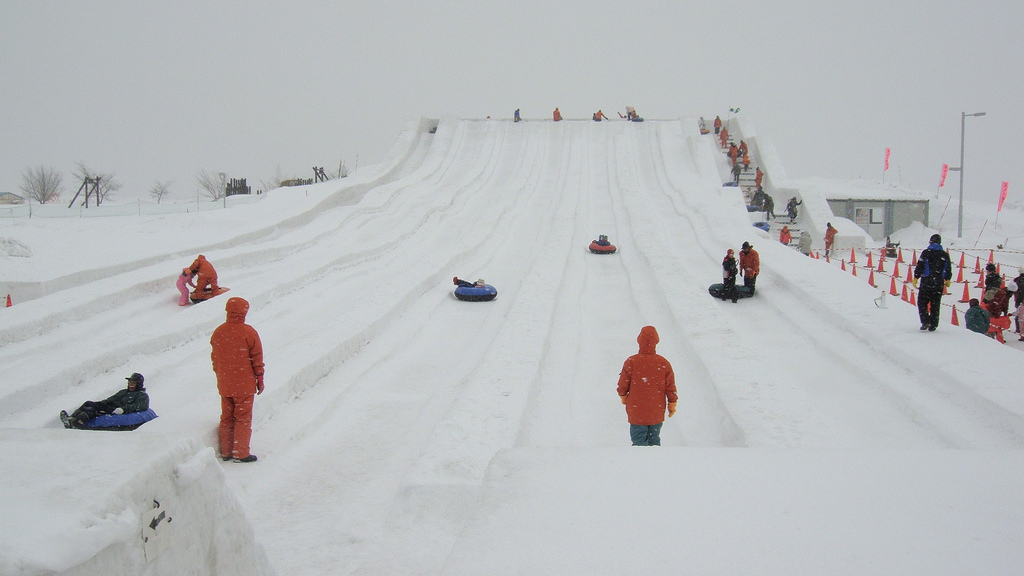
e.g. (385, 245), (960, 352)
(442, 448), (1024, 575)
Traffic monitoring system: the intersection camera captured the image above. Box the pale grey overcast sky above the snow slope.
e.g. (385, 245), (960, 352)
(0, 0), (1024, 203)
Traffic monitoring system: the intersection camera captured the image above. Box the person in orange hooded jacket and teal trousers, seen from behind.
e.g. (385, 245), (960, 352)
(616, 326), (679, 446)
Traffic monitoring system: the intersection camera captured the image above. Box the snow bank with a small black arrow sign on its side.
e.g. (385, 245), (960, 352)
(0, 429), (275, 576)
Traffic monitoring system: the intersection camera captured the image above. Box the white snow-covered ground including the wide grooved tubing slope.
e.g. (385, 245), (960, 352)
(0, 118), (1024, 575)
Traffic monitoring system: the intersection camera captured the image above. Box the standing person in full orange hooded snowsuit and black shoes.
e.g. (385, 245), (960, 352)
(210, 297), (263, 462)
